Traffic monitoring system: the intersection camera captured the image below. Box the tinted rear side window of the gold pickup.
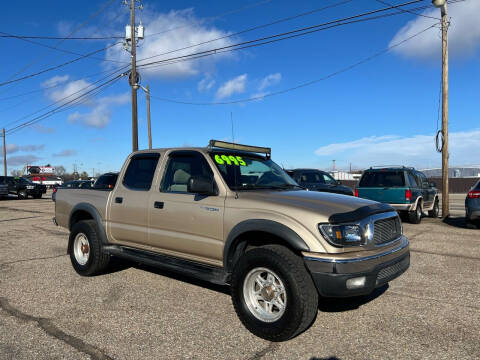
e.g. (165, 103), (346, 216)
(123, 153), (160, 191)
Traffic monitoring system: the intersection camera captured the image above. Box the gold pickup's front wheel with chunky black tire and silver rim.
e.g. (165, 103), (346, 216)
(231, 245), (318, 341)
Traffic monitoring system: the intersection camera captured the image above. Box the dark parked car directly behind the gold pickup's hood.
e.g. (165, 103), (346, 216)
(286, 169), (353, 195)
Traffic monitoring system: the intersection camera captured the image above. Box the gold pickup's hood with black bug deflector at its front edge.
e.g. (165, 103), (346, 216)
(239, 190), (393, 223)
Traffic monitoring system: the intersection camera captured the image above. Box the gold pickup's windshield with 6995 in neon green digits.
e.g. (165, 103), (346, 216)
(210, 152), (301, 190)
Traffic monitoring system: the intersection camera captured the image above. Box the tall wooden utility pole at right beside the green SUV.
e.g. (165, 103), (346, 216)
(432, 0), (450, 218)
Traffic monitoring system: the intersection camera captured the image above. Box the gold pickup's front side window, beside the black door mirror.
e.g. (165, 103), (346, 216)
(161, 151), (213, 193)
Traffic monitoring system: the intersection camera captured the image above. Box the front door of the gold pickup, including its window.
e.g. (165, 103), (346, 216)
(148, 150), (225, 264)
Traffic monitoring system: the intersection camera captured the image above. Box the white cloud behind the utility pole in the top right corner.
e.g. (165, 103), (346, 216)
(390, 1), (480, 59)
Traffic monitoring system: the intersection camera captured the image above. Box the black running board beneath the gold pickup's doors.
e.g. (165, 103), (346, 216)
(103, 245), (228, 285)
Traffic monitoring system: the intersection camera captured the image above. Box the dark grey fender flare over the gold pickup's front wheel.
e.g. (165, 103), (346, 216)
(223, 219), (310, 272)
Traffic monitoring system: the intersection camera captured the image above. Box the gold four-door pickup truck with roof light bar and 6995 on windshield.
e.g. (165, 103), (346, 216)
(54, 140), (410, 341)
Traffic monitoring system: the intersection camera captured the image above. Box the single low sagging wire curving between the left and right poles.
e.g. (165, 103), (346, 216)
(150, 23), (438, 105)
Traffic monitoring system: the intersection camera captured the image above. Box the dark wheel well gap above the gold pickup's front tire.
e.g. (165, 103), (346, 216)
(226, 231), (299, 272)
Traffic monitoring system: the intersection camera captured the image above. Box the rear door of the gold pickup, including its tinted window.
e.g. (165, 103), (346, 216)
(106, 153), (160, 245)
